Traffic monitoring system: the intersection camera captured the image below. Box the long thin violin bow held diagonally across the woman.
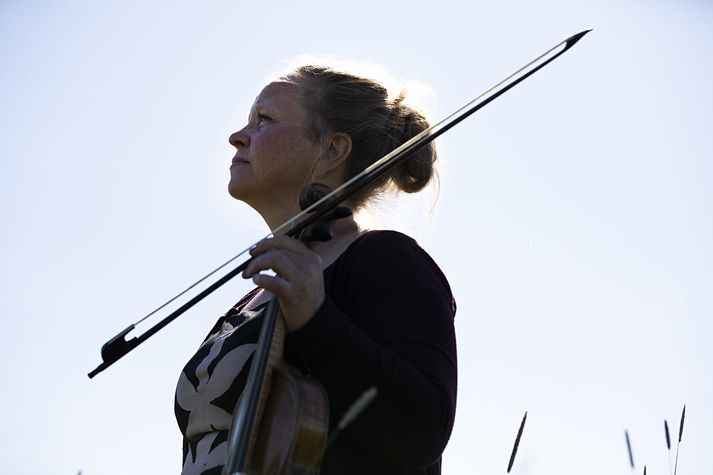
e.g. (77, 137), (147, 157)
(88, 30), (591, 378)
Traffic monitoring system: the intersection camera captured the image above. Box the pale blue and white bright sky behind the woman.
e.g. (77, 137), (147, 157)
(0, 0), (713, 475)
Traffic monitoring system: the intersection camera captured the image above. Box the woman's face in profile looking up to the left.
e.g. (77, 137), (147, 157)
(228, 83), (320, 212)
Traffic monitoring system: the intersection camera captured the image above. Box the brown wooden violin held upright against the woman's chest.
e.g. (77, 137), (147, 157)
(223, 183), (352, 475)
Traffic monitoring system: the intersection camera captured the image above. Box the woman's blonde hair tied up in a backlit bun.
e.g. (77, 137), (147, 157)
(276, 65), (436, 207)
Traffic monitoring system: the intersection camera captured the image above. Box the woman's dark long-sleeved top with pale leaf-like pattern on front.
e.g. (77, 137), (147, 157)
(176, 231), (457, 475)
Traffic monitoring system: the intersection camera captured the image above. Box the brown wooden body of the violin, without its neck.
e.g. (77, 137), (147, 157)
(248, 363), (329, 475)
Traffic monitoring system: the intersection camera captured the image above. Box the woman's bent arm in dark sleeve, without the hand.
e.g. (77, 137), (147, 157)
(287, 232), (457, 468)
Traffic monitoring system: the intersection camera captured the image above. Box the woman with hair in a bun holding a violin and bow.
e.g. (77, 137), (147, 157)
(175, 66), (457, 475)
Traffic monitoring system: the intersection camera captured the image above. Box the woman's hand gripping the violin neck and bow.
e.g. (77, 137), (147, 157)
(243, 236), (324, 332)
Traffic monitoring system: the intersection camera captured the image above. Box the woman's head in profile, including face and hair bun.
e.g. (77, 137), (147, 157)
(229, 61), (436, 221)
